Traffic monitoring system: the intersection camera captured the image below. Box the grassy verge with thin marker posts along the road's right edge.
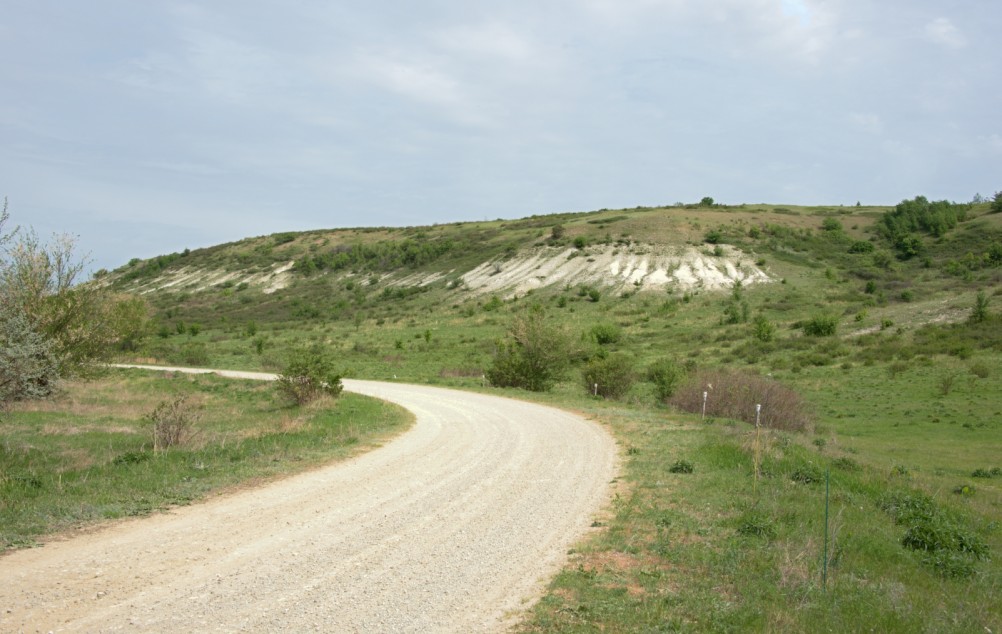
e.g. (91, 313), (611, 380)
(517, 399), (1002, 633)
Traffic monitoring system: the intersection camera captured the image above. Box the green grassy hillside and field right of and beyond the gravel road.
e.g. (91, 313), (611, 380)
(9, 199), (1002, 632)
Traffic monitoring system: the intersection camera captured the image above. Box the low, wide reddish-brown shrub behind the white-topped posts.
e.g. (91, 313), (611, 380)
(669, 370), (814, 431)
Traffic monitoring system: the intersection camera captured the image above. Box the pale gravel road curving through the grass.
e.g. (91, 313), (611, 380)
(0, 373), (617, 632)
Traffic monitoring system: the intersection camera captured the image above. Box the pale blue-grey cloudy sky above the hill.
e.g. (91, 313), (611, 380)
(0, 0), (1002, 269)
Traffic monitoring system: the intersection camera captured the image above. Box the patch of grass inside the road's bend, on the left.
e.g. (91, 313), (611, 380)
(0, 370), (410, 550)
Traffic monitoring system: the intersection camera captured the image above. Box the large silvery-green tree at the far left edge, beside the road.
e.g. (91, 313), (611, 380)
(0, 198), (148, 403)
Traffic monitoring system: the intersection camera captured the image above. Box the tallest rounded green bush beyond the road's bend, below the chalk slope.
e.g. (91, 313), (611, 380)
(486, 304), (570, 392)
